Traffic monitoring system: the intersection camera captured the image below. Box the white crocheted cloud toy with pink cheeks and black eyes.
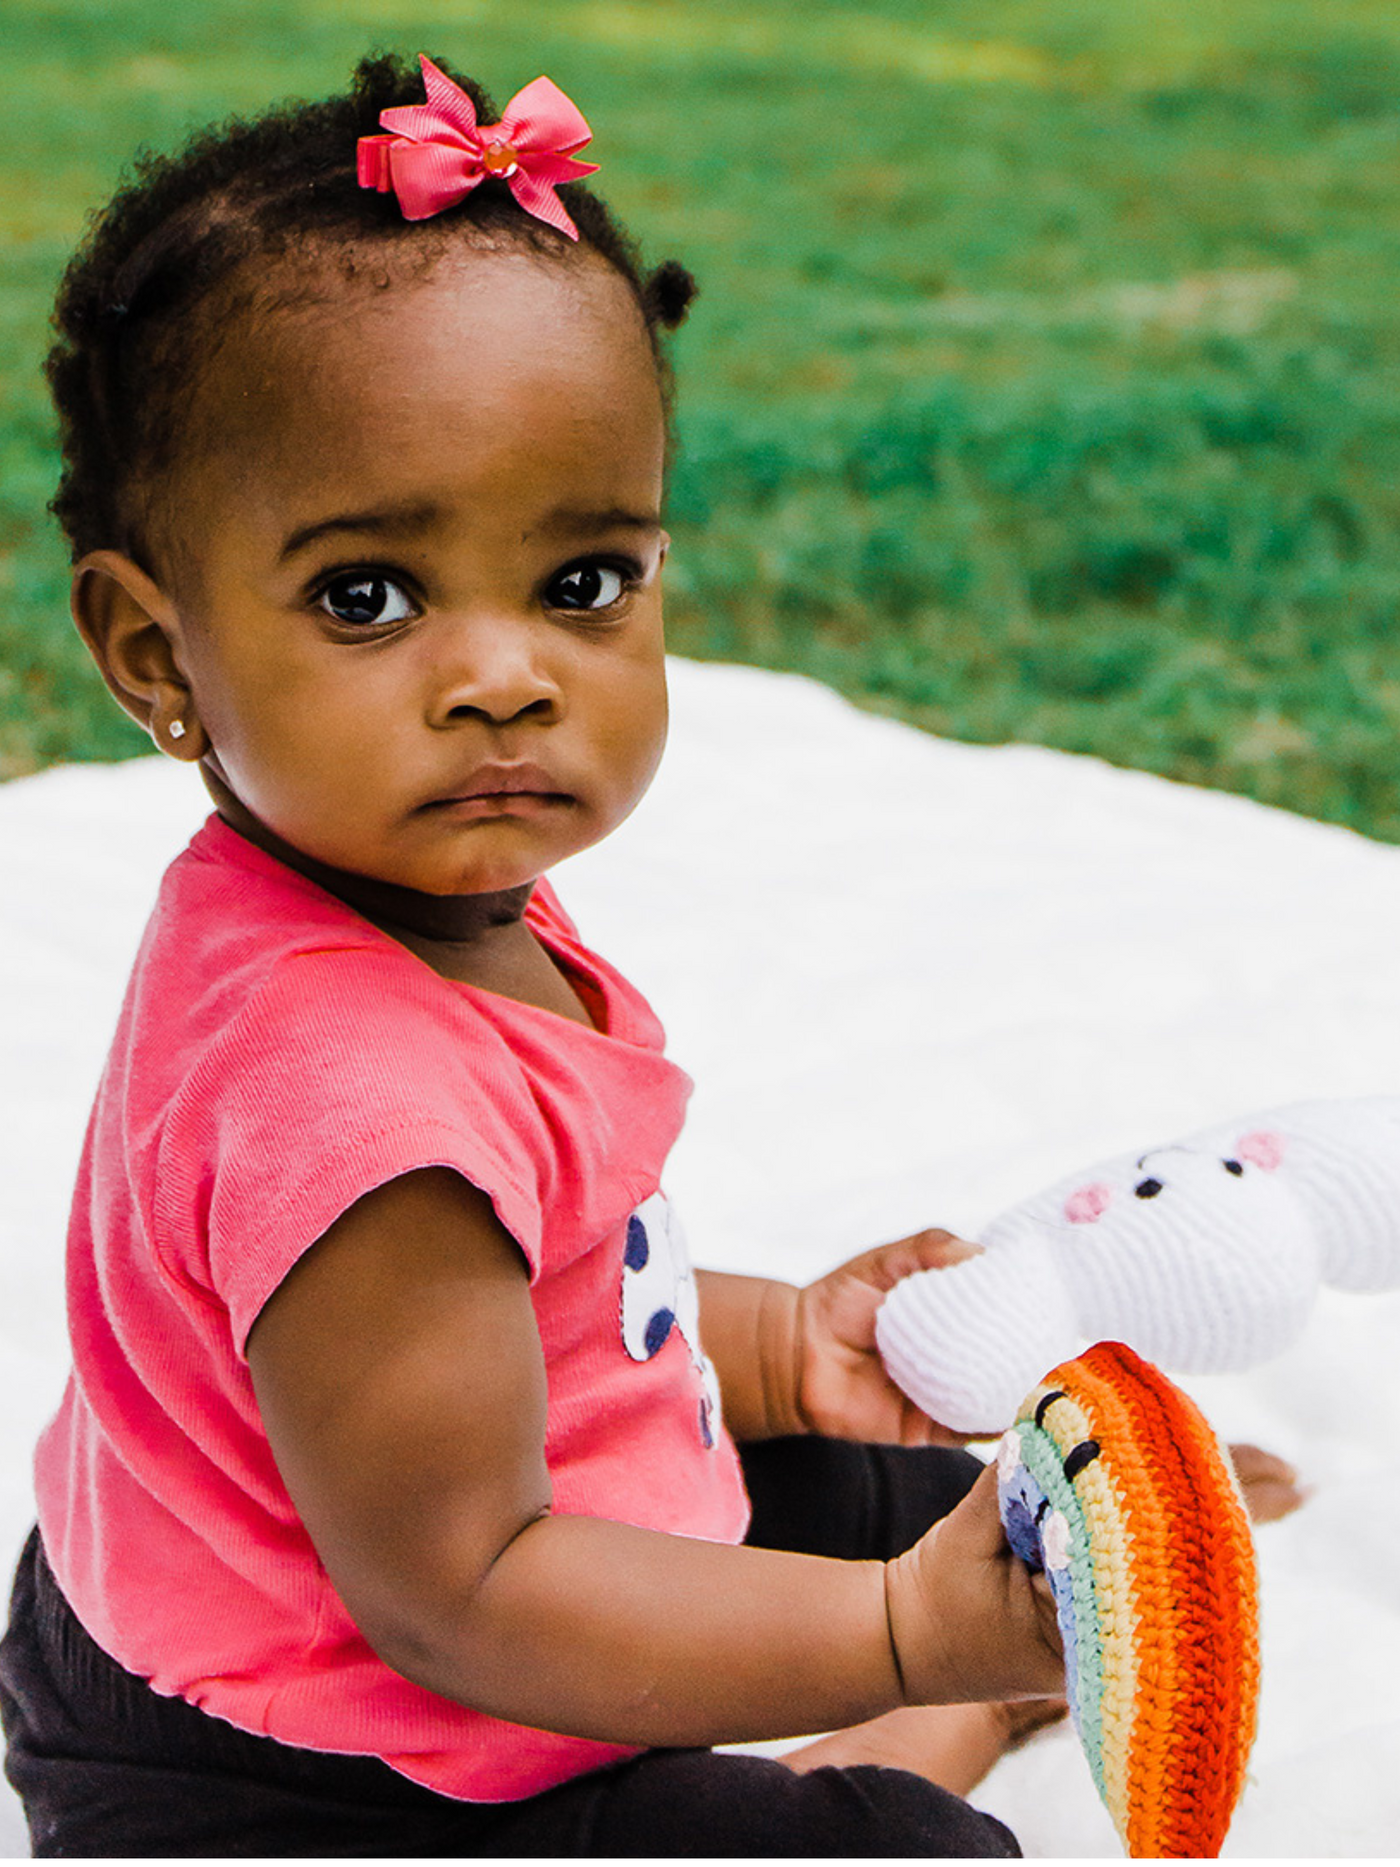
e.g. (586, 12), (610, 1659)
(875, 1096), (1400, 1432)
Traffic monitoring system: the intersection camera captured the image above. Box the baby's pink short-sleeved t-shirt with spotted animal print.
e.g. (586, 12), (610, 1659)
(35, 818), (747, 1802)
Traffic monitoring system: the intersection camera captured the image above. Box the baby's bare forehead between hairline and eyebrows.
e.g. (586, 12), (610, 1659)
(172, 250), (665, 563)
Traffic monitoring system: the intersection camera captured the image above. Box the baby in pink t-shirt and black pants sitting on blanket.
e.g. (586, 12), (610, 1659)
(0, 58), (1062, 1856)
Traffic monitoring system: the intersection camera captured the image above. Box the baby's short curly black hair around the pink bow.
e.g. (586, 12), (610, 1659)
(47, 54), (696, 558)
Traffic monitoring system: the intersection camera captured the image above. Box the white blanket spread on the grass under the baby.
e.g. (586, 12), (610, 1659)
(0, 663), (1400, 1858)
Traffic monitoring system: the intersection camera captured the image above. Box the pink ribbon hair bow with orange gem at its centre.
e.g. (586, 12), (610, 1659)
(355, 54), (597, 239)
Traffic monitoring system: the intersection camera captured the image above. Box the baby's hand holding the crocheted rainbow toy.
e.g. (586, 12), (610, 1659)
(885, 1466), (1064, 1705)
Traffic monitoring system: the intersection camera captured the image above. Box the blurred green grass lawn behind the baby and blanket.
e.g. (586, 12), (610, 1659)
(0, 0), (1400, 840)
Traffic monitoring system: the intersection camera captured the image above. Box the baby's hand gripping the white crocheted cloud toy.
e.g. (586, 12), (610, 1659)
(795, 1230), (980, 1445)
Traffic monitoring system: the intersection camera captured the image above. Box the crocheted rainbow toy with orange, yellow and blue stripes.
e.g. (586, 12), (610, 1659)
(997, 1342), (1258, 1860)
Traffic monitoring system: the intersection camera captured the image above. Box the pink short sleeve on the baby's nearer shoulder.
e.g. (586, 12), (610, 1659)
(151, 948), (547, 1355)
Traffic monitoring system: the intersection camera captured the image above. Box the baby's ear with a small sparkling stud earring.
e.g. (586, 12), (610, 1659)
(71, 551), (209, 764)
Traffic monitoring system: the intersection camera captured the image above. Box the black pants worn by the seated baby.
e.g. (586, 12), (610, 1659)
(0, 1439), (1019, 1858)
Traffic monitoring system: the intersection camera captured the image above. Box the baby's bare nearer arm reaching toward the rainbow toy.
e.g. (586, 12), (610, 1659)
(248, 1169), (1053, 1746)
